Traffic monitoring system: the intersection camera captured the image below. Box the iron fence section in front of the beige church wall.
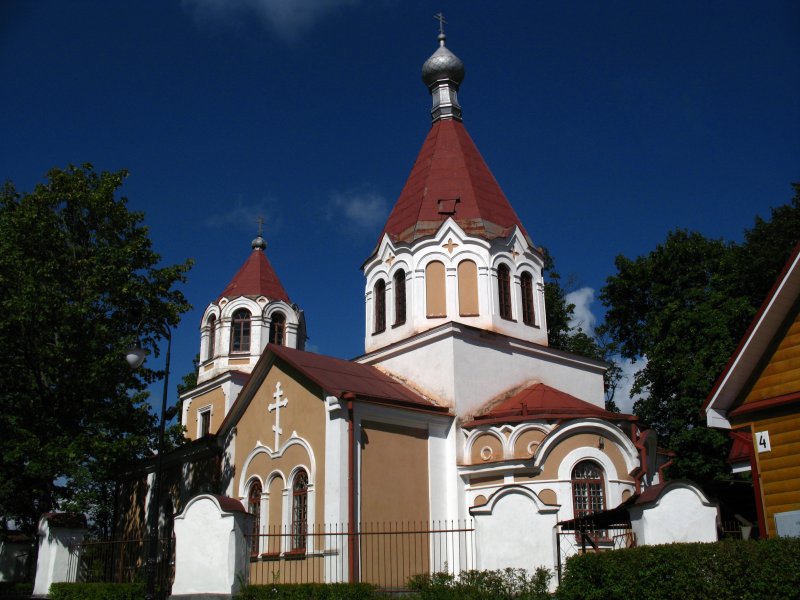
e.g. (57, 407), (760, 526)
(245, 521), (475, 591)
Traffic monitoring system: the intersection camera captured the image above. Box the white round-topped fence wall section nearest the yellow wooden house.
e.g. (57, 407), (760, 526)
(628, 481), (719, 546)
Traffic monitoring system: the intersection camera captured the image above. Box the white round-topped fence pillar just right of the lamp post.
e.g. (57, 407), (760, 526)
(171, 494), (249, 598)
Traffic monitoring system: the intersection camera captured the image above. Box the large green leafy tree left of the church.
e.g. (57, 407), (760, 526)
(0, 165), (191, 531)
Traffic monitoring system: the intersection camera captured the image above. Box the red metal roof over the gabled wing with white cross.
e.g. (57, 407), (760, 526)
(267, 344), (448, 412)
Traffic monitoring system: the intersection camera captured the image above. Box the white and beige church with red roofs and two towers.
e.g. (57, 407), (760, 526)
(121, 27), (676, 570)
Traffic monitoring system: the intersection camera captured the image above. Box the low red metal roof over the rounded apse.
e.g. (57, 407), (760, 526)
(464, 383), (636, 427)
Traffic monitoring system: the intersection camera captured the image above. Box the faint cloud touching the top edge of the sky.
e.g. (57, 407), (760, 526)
(183, 0), (359, 39)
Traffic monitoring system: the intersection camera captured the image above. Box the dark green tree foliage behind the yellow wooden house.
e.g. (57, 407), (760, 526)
(600, 186), (800, 482)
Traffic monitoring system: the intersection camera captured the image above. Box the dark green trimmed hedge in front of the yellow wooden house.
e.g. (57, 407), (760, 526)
(556, 538), (800, 600)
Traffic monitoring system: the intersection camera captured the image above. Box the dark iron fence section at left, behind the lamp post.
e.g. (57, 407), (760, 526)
(68, 536), (175, 598)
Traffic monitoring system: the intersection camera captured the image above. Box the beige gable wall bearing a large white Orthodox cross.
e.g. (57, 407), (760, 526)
(233, 361), (328, 525)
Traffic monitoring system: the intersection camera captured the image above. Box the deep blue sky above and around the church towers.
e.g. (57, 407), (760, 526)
(0, 0), (800, 410)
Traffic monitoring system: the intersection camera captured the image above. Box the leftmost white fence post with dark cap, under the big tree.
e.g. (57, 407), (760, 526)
(33, 513), (86, 597)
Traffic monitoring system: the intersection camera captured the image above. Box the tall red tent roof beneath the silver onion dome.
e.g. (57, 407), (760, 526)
(379, 119), (530, 248)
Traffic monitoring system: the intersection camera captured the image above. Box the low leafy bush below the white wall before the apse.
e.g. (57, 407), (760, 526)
(408, 567), (552, 600)
